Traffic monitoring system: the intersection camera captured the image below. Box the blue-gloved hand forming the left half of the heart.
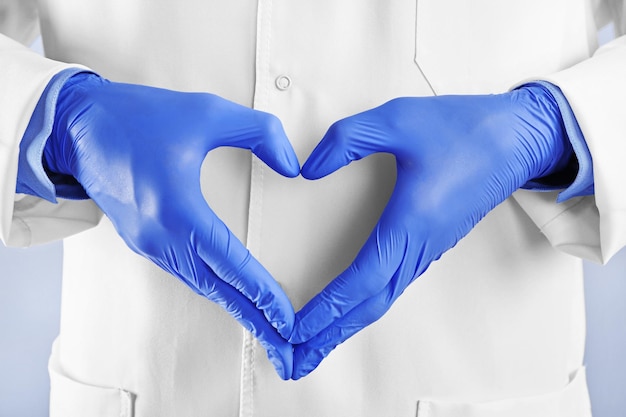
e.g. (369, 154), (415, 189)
(44, 73), (300, 379)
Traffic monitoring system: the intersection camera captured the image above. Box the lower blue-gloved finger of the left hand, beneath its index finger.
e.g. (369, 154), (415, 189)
(199, 267), (293, 380)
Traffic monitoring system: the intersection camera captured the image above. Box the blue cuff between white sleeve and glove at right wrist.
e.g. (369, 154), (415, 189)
(523, 81), (594, 203)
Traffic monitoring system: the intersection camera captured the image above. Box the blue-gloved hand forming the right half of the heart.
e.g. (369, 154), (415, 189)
(289, 85), (572, 379)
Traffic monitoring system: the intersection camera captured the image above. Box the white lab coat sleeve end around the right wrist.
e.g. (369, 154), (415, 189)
(514, 36), (626, 263)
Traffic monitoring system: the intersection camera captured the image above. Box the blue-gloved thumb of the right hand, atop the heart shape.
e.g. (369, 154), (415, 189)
(301, 111), (390, 180)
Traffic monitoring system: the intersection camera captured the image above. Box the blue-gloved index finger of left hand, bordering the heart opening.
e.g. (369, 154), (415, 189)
(192, 209), (295, 338)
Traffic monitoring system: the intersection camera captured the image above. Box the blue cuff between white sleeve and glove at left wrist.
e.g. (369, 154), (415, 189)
(16, 68), (87, 203)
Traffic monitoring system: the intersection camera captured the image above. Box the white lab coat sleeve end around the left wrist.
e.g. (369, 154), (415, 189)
(0, 34), (101, 246)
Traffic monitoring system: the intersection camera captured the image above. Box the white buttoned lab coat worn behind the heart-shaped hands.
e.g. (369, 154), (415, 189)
(0, 0), (626, 417)
